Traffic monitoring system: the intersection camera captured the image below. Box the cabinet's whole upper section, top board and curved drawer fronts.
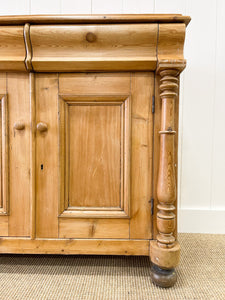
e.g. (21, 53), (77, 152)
(0, 15), (190, 72)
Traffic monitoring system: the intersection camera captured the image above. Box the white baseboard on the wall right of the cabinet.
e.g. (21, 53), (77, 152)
(178, 208), (225, 234)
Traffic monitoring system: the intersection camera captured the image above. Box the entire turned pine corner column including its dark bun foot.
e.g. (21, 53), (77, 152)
(150, 67), (180, 287)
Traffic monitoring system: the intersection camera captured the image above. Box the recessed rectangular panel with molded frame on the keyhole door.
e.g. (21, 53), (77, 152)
(59, 94), (131, 218)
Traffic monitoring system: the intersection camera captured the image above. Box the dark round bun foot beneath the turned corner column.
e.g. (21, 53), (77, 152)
(151, 264), (177, 288)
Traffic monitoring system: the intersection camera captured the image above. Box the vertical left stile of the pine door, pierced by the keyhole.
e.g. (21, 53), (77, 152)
(36, 74), (59, 238)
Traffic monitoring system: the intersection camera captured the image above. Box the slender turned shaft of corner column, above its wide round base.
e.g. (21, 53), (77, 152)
(157, 69), (179, 248)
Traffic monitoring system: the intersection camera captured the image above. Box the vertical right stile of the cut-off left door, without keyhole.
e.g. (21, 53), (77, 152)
(7, 73), (30, 236)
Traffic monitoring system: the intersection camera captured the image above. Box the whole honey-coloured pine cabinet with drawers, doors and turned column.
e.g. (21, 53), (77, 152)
(0, 15), (190, 286)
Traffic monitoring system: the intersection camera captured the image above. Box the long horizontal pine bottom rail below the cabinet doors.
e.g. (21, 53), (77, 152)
(0, 238), (149, 256)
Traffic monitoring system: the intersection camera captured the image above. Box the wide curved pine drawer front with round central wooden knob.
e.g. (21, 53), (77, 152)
(30, 24), (158, 72)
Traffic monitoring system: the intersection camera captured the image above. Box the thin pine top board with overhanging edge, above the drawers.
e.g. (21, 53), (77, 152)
(0, 14), (191, 25)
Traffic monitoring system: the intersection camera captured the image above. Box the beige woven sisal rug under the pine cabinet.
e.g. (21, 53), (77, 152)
(0, 233), (225, 300)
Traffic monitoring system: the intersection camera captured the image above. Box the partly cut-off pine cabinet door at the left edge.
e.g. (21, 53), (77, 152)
(0, 72), (31, 237)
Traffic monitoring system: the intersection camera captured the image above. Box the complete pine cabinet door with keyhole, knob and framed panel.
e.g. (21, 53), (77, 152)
(36, 73), (154, 239)
